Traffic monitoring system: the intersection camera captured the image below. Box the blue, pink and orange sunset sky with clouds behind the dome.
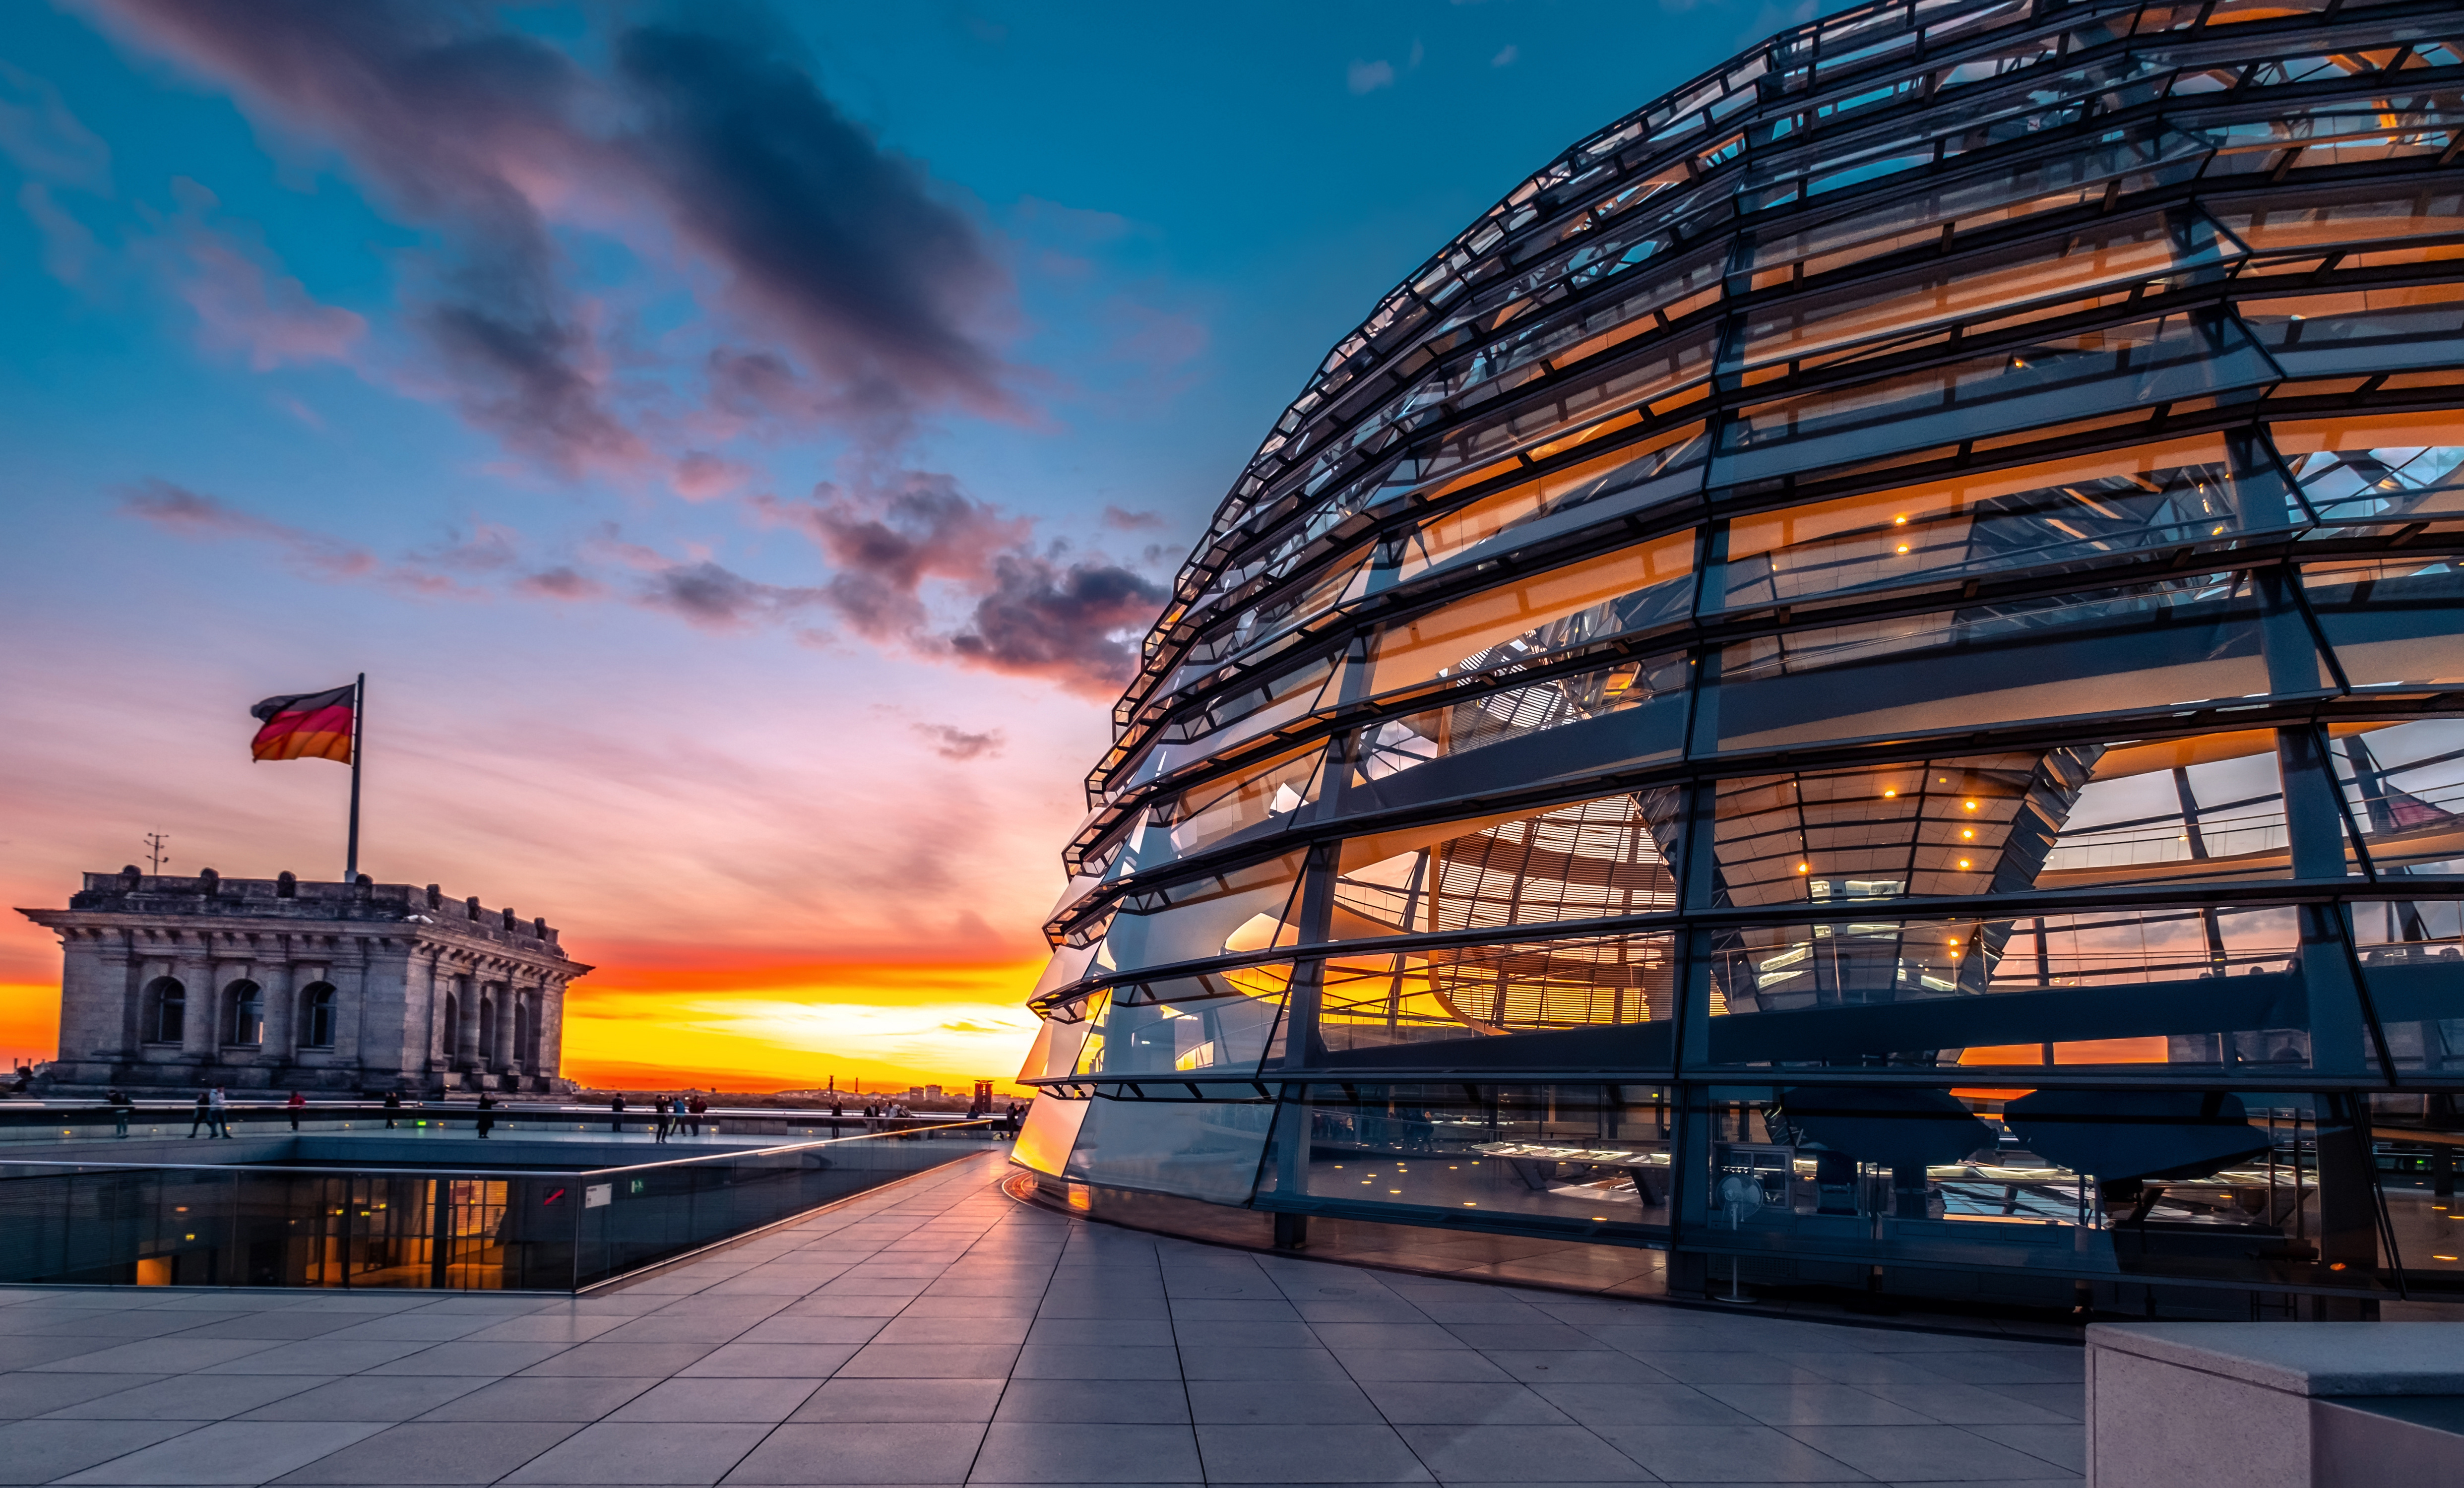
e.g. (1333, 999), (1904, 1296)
(0, 0), (1814, 1089)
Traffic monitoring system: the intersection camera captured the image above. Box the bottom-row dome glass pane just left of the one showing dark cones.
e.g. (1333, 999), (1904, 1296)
(1259, 1084), (1671, 1232)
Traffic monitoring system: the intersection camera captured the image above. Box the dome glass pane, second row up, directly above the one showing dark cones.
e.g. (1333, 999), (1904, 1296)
(1710, 907), (2343, 1074)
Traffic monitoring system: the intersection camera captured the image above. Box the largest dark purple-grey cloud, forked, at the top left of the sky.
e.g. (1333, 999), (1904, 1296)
(96, 0), (1010, 471)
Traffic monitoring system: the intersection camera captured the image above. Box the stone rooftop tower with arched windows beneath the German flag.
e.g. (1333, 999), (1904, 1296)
(20, 867), (589, 1094)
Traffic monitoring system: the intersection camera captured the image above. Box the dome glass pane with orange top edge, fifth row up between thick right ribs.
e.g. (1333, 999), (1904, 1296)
(1722, 434), (2289, 609)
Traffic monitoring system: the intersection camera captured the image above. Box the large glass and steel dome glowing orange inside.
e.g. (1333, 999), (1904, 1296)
(1020, 0), (2464, 1315)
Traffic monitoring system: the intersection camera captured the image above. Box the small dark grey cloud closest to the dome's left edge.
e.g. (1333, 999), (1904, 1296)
(948, 552), (1165, 697)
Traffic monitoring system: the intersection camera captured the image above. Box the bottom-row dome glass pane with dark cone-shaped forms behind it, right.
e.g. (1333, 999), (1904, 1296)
(1700, 1084), (2378, 1308)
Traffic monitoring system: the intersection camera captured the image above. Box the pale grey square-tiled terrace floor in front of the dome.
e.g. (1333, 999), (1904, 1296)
(0, 1155), (2085, 1486)
